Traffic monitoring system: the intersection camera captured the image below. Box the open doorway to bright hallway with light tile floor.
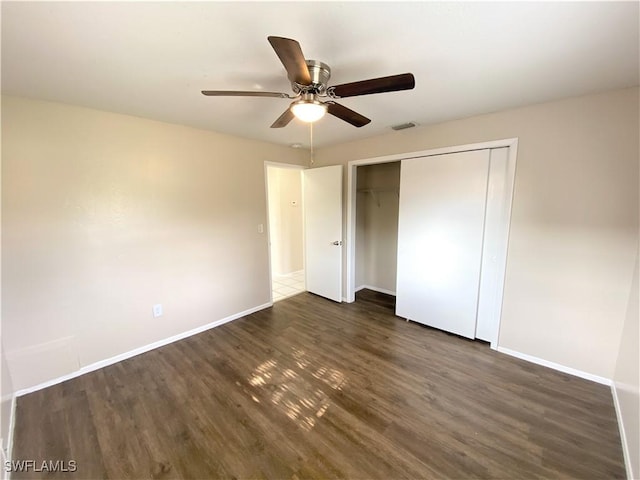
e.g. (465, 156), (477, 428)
(266, 164), (306, 302)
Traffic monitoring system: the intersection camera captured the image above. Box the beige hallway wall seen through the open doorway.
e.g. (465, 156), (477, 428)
(267, 166), (304, 275)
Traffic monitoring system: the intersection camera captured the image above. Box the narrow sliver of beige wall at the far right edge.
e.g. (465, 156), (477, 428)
(613, 253), (640, 478)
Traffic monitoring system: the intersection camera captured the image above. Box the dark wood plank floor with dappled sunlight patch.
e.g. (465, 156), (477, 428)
(12, 292), (625, 479)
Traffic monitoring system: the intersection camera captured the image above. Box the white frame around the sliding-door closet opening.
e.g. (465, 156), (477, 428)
(344, 138), (518, 350)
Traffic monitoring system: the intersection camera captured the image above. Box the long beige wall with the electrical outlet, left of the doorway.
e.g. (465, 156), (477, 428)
(2, 97), (304, 389)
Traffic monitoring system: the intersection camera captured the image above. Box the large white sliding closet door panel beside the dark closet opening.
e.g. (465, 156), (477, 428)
(396, 150), (490, 338)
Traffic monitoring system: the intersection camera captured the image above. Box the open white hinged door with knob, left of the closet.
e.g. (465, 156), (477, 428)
(303, 165), (342, 302)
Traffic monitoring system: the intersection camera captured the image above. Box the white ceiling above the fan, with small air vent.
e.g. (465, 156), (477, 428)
(2, 2), (640, 146)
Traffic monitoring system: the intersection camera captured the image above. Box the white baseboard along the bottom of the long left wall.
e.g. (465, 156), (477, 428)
(15, 302), (273, 397)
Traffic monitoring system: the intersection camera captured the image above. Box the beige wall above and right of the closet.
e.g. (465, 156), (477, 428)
(316, 88), (639, 379)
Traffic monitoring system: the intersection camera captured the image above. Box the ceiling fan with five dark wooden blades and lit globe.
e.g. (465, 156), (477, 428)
(202, 36), (415, 128)
